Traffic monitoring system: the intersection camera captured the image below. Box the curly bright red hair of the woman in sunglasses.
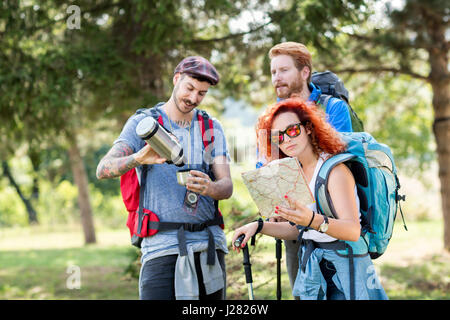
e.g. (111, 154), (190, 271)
(256, 98), (346, 160)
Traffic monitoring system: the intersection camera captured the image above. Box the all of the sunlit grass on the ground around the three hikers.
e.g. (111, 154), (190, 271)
(0, 220), (450, 300)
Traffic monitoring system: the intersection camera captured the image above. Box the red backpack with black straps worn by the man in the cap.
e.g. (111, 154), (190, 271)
(120, 103), (225, 250)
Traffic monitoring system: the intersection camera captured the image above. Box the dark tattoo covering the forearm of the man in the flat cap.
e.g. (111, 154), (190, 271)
(97, 142), (139, 179)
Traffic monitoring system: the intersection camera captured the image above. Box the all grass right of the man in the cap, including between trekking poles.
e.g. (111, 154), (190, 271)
(227, 219), (450, 300)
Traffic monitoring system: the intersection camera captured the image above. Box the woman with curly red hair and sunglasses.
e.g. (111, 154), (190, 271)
(232, 98), (387, 300)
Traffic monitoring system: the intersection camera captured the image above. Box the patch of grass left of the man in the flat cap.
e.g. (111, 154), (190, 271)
(0, 227), (138, 300)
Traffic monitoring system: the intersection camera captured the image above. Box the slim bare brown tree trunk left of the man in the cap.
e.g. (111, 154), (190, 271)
(68, 135), (96, 244)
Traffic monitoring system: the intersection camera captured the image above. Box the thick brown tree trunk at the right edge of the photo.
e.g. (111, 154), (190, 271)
(429, 20), (450, 251)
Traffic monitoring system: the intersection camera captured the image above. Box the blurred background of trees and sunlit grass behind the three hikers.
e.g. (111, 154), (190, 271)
(0, 0), (450, 299)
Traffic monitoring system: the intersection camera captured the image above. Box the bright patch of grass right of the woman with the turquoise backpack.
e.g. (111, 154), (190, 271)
(374, 219), (450, 300)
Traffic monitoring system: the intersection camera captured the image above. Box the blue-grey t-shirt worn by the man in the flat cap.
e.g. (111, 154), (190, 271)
(114, 107), (230, 261)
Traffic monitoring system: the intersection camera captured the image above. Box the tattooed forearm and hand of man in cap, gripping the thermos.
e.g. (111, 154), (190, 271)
(97, 142), (166, 179)
